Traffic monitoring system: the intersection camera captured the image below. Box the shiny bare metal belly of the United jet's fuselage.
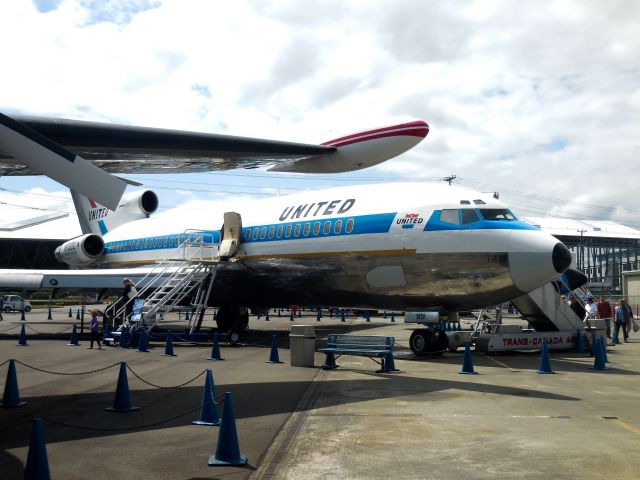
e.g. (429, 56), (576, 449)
(210, 251), (521, 310)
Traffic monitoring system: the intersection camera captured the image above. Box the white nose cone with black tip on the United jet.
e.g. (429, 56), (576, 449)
(509, 232), (571, 293)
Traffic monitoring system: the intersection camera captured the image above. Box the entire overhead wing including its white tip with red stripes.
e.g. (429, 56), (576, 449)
(0, 115), (429, 175)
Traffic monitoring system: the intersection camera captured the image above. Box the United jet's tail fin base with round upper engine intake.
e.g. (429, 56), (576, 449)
(71, 190), (158, 236)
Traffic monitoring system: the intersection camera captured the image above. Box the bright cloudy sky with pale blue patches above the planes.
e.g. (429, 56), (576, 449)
(0, 0), (640, 232)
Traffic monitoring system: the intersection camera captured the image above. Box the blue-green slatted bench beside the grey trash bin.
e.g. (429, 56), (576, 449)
(318, 334), (398, 373)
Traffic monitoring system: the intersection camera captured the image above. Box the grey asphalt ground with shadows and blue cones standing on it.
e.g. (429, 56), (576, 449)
(0, 313), (640, 480)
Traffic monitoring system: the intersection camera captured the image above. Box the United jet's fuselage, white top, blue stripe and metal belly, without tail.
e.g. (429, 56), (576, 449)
(96, 183), (568, 310)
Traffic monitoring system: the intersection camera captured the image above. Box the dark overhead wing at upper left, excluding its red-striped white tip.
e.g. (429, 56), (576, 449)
(0, 115), (336, 175)
